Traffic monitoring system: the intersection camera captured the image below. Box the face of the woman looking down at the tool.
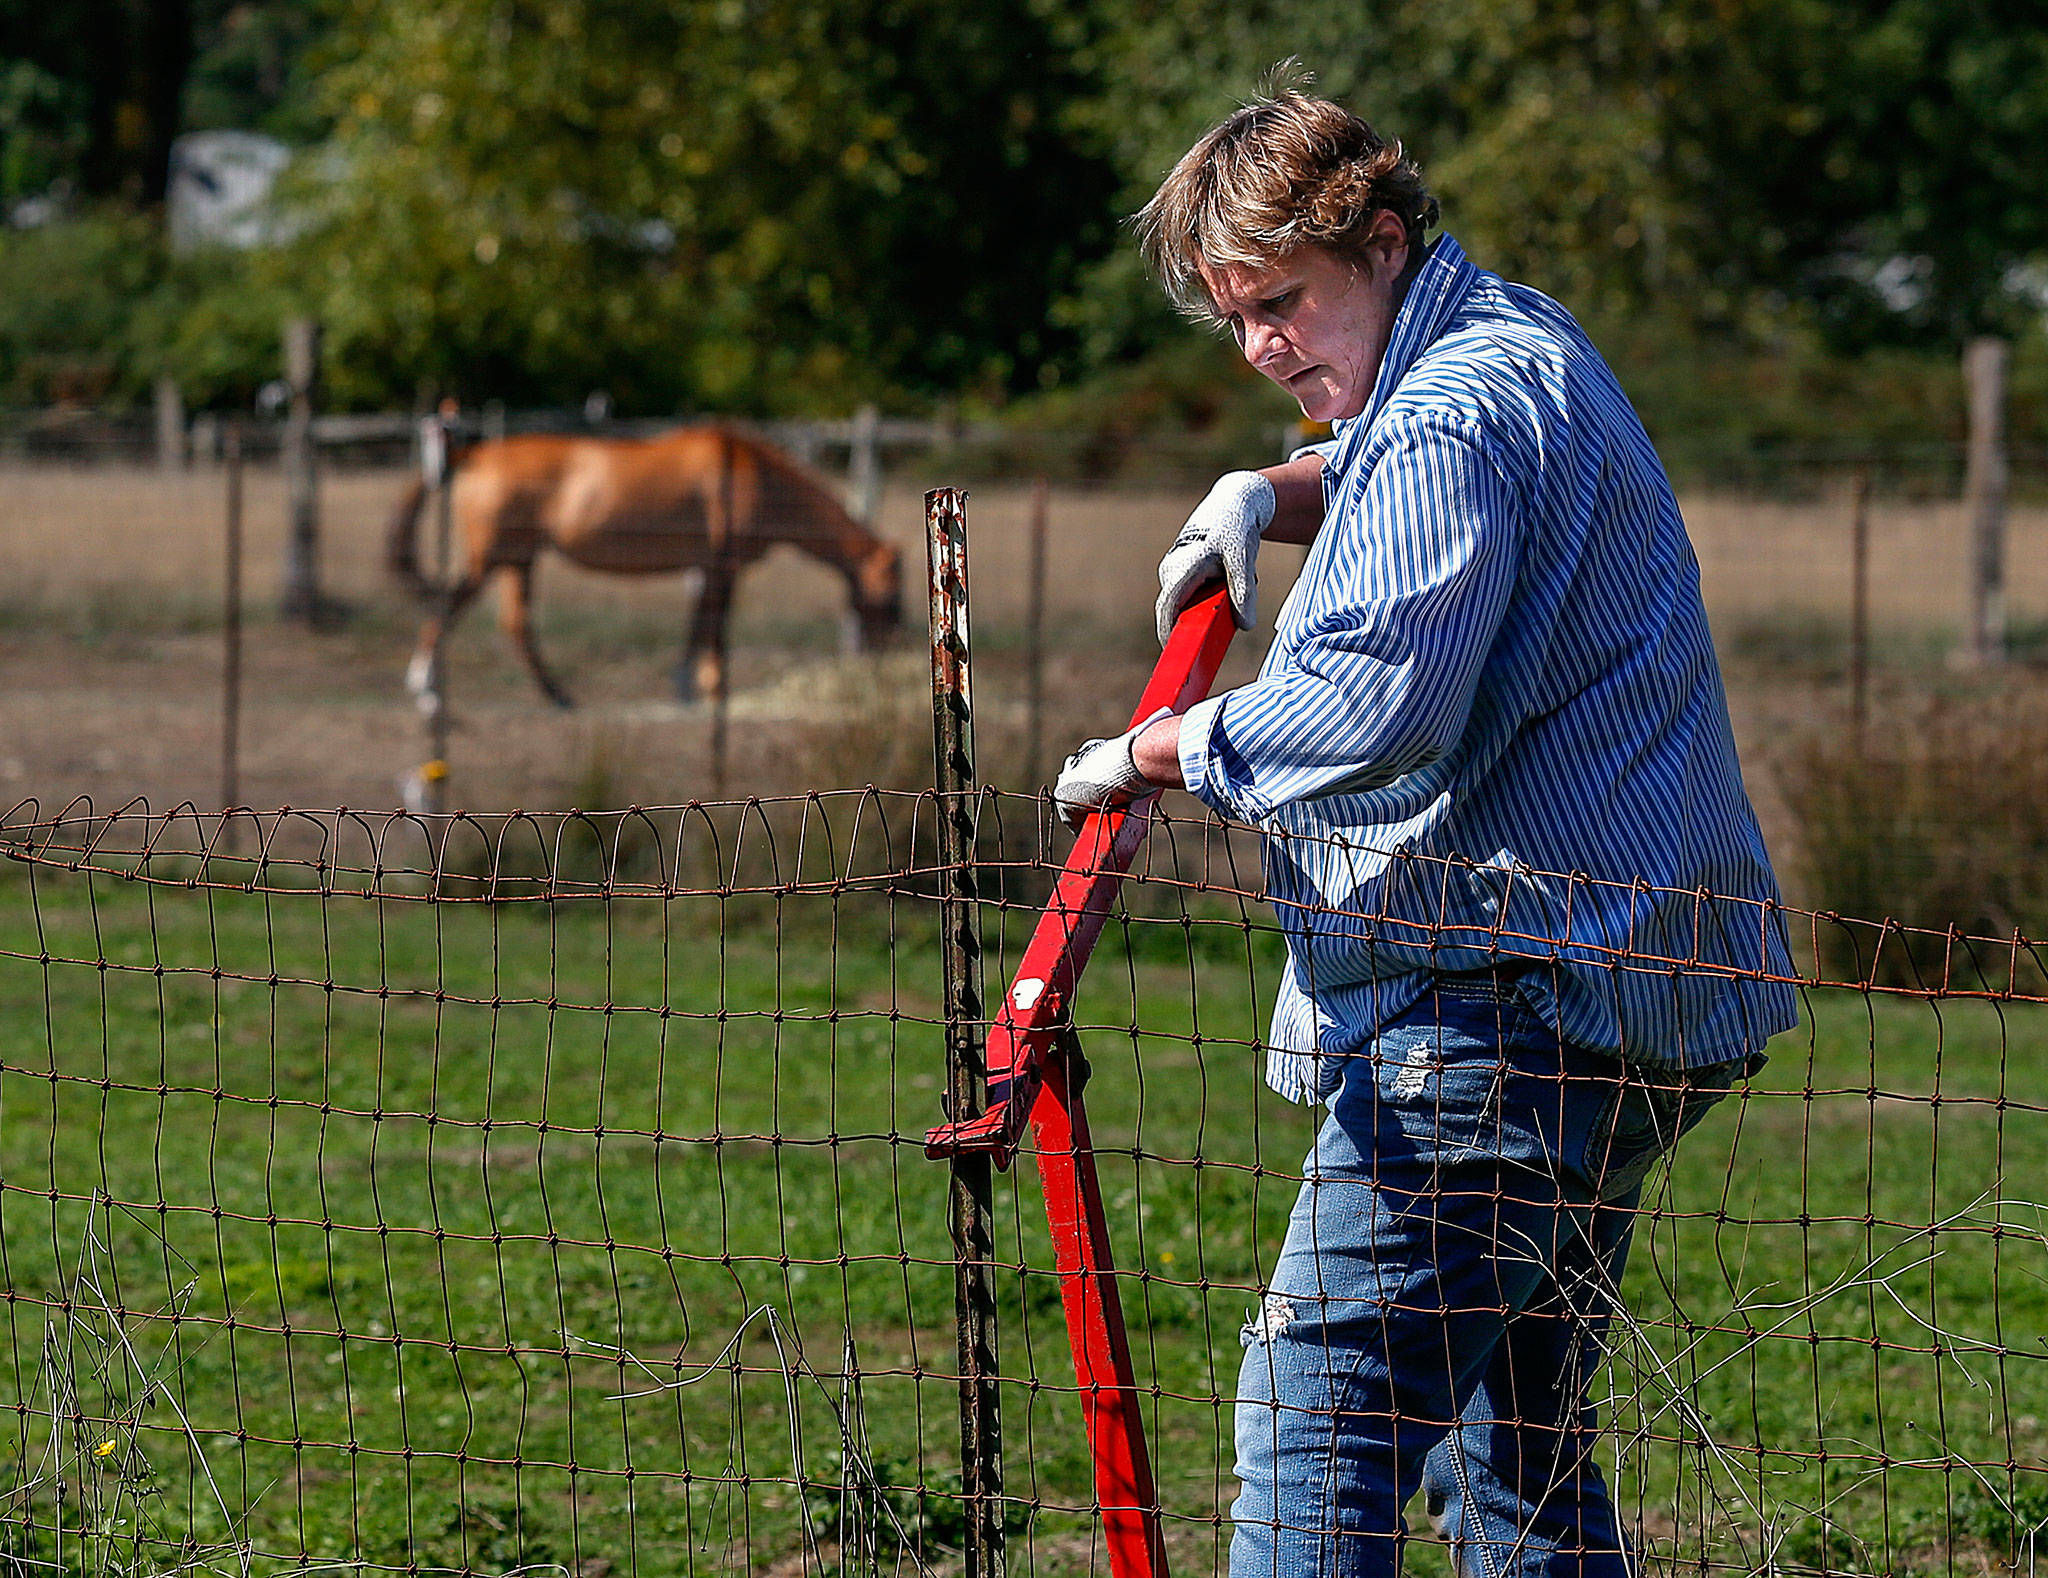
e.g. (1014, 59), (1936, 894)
(1202, 224), (1407, 422)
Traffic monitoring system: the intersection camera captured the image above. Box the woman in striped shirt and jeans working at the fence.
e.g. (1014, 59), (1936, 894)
(1055, 90), (1794, 1578)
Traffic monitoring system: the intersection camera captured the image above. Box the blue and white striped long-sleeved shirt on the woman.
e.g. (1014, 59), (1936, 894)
(1180, 235), (1796, 1099)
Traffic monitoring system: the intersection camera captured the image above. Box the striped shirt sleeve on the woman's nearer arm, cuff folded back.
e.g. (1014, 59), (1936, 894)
(1180, 420), (1522, 821)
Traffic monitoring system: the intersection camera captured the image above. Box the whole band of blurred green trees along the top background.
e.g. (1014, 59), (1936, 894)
(12, 0), (2048, 431)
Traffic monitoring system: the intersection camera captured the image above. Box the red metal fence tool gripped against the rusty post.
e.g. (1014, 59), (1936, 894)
(924, 587), (1235, 1578)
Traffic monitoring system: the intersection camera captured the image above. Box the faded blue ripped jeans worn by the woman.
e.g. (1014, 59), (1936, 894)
(1231, 972), (1743, 1578)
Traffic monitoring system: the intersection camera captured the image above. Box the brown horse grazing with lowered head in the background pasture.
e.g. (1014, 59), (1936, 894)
(387, 426), (903, 706)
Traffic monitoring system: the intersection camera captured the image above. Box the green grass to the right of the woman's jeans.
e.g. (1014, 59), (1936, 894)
(1618, 993), (2048, 1572)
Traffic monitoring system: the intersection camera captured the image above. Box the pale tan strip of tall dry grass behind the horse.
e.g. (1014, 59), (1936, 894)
(16, 465), (2048, 637)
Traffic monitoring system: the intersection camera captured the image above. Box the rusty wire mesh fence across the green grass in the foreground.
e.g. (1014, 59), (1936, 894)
(0, 790), (2048, 1578)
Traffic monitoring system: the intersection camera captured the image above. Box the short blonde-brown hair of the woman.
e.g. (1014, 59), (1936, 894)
(1137, 77), (1438, 319)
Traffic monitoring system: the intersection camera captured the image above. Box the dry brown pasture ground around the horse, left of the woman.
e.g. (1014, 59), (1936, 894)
(0, 467), (1298, 808)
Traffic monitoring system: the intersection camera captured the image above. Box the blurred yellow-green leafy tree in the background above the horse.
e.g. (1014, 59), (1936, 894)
(276, 0), (1110, 411)
